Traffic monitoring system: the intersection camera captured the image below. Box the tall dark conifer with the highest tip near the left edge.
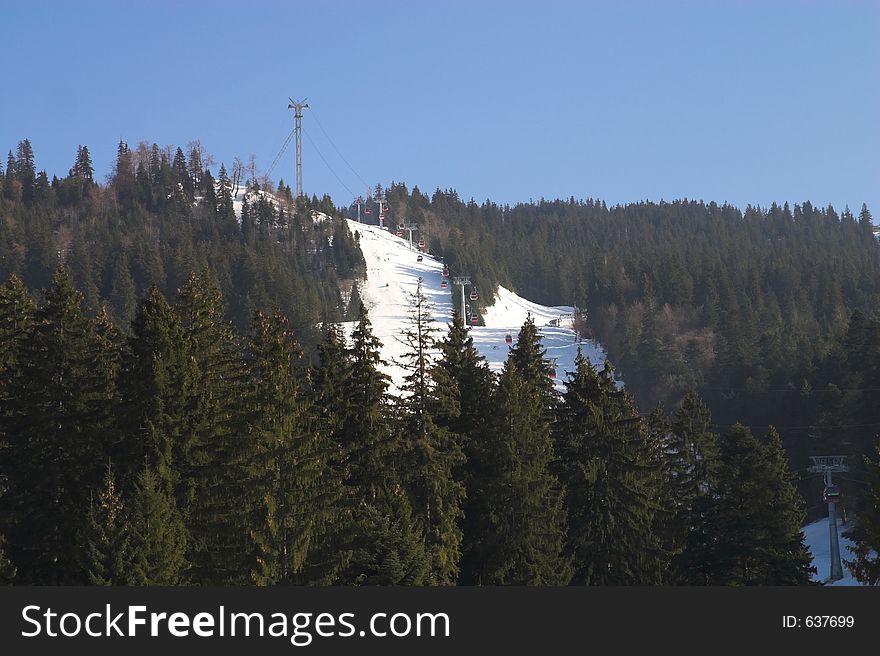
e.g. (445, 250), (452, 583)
(3, 269), (115, 584)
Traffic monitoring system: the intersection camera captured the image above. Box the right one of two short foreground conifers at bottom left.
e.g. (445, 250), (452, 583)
(126, 466), (188, 585)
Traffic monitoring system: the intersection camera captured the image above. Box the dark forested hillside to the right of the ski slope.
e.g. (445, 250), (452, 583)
(385, 184), (880, 510)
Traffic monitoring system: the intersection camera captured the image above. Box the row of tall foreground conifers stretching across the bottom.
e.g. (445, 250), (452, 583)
(0, 268), (876, 585)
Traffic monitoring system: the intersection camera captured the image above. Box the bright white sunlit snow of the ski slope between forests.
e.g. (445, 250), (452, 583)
(346, 220), (605, 390)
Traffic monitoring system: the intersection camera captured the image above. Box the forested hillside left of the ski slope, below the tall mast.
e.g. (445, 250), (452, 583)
(0, 140), (363, 345)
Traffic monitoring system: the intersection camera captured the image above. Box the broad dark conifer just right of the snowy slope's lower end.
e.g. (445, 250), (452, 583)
(557, 353), (665, 585)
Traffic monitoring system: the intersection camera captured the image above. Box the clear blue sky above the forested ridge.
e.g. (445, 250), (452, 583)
(0, 0), (880, 217)
